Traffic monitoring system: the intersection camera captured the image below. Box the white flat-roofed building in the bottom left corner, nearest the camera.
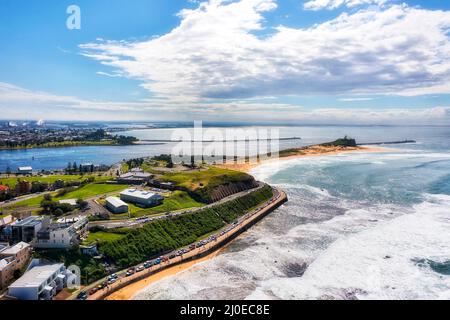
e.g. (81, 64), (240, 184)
(8, 263), (75, 300)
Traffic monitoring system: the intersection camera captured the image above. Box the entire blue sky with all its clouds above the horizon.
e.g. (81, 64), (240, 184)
(0, 0), (450, 125)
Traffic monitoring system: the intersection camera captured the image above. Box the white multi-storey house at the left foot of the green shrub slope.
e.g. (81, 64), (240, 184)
(33, 217), (89, 249)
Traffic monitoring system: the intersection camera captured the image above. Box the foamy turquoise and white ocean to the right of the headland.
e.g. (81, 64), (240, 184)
(127, 128), (450, 300)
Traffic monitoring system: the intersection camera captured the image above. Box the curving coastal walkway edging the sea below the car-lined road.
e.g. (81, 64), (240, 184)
(79, 188), (288, 300)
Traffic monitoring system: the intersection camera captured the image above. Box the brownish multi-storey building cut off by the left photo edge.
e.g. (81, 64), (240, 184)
(0, 242), (31, 289)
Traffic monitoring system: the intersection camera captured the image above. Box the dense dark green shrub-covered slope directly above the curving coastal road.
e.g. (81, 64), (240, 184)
(100, 186), (273, 267)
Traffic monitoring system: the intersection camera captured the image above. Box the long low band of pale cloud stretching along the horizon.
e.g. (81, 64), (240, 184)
(0, 82), (450, 125)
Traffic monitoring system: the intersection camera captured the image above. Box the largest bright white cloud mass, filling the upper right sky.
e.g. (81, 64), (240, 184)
(81, 0), (450, 101)
